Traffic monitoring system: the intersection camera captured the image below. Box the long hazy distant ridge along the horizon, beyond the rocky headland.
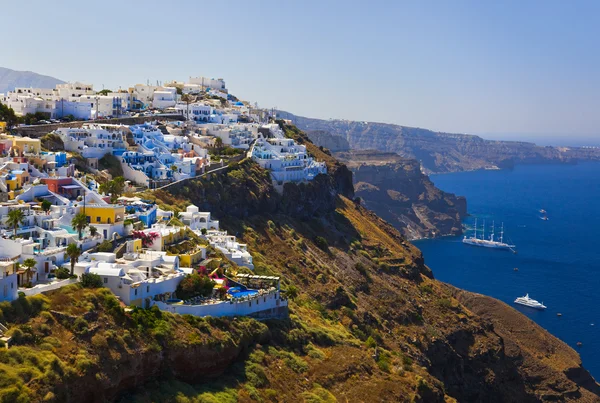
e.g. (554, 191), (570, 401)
(278, 112), (600, 172)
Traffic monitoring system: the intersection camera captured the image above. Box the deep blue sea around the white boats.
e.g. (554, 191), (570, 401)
(414, 163), (600, 379)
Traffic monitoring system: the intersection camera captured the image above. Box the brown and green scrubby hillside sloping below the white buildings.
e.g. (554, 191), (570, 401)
(0, 127), (600, 403)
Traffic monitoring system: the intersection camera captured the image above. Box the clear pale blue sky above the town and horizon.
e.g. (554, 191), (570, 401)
(0, 0), (600, 142)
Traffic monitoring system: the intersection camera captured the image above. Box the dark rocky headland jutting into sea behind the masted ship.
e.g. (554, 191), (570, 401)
(336, 151), (467, 239)
